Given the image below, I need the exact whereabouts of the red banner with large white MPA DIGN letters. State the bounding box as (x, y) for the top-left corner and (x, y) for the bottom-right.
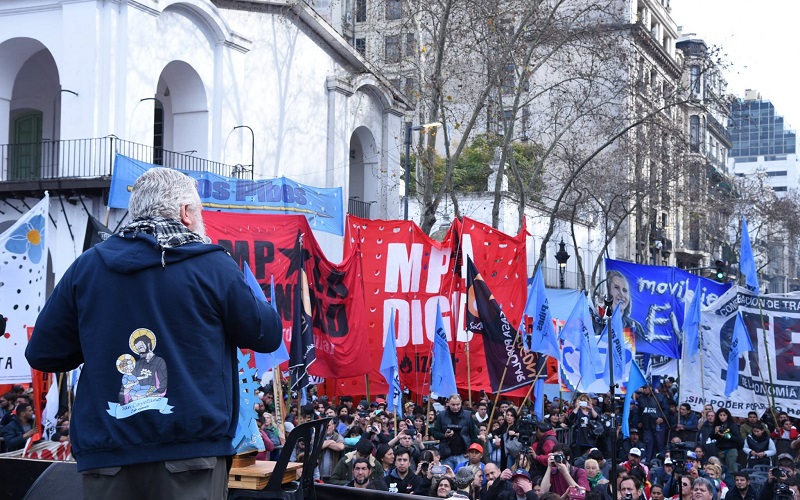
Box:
(336, 216), (527, 396)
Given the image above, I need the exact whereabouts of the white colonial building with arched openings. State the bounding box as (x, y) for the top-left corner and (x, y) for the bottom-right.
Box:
(0, 0), (408, 282)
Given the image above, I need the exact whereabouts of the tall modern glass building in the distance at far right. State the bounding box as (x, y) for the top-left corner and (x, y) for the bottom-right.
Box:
(730, 90), (800, 196)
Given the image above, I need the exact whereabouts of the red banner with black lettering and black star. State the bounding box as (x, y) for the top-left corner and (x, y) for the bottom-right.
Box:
(203, 211), (371, 378)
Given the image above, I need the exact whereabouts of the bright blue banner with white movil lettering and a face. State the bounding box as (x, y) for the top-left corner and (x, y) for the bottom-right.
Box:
(606, 259), (730, 358)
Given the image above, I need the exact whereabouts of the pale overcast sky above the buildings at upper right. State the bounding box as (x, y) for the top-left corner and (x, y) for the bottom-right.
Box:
(671, 0), (800, 130)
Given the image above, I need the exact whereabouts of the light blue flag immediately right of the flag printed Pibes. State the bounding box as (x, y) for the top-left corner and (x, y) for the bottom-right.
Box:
(559, 294), (605, 392)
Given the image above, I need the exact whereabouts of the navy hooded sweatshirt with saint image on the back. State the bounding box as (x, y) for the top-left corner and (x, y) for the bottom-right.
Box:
(26, 232), (281, 471)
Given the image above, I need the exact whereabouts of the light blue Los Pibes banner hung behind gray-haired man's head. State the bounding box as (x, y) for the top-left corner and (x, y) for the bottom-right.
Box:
(108, 154), (344, 236)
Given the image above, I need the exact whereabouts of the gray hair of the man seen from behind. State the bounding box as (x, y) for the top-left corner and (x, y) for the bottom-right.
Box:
(128, 167), (197, 220)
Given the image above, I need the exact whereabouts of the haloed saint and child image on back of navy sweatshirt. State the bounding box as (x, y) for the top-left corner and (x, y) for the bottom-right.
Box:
(106, 328), (172, 419)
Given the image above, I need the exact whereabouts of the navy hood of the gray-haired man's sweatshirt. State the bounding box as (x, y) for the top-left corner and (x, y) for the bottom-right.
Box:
(93, 233), (225, 274)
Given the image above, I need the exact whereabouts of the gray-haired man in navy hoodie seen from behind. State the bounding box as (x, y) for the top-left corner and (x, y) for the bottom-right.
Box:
(25, 167), (282, 498)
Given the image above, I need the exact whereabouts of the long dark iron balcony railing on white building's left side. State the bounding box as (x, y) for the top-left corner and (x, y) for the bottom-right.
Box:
(0, 136), (244, 182)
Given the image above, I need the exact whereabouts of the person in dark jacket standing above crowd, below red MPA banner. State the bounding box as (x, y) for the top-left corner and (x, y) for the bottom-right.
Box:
(431, 394), (478, 469)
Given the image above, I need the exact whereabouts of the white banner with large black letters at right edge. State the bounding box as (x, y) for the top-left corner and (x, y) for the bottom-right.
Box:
(681, 287), (800, 417)
